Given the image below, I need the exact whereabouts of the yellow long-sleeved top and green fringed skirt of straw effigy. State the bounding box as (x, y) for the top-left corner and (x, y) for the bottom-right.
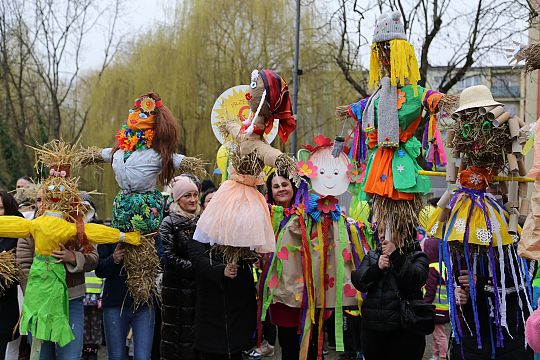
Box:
(0, 211), (141, 346)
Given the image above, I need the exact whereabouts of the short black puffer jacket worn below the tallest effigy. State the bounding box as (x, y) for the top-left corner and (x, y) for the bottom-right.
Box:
(351, 243), (429, 331)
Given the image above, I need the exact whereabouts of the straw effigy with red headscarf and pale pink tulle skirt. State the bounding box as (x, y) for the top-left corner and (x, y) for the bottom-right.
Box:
(193, 70), (296, 263)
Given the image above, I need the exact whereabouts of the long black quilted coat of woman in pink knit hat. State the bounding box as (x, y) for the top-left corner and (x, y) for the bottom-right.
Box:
(159, 213), (197, 360)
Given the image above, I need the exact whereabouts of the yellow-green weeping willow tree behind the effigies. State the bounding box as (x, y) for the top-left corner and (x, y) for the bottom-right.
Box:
(78, 0), (356, 216)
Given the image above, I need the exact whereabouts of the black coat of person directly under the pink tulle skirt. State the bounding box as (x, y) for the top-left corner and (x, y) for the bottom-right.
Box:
(188, 240), (257, 355)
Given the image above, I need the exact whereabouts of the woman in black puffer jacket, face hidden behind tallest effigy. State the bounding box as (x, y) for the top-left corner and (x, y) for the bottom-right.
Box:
(351, 227), (429, 360)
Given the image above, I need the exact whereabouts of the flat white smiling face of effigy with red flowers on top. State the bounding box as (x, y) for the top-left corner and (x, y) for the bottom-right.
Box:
(309, 146), (349, 196)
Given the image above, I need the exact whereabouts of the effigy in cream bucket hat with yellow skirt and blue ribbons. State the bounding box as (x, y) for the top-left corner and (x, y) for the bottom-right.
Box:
(428, 85), (531, 348)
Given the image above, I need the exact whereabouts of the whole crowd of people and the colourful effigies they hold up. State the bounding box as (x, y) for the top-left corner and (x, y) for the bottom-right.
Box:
(0, 7), (540, 360)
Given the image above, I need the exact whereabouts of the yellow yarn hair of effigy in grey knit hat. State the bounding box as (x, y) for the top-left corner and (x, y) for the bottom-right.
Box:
(369, 39), (420, 96)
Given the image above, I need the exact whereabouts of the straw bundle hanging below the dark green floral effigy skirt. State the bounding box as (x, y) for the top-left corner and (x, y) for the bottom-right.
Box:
(123, 234), (161, 309)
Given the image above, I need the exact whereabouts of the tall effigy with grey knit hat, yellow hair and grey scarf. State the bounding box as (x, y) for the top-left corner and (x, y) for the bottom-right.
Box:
(337, 12), (454, 245)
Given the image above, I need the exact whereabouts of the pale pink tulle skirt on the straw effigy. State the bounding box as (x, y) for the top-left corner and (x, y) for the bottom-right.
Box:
(193, 174), (276, 253)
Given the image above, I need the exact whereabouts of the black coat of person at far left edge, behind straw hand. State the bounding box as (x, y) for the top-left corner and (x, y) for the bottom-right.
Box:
(0, 238), (19, 338)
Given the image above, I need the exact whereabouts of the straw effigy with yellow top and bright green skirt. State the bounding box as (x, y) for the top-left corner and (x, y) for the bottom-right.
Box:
(0, 141), (141, 354)
